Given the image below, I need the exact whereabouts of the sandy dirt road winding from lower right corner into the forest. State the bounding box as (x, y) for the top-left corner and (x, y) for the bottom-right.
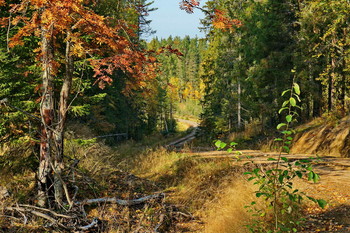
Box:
(168, 123), (350, 233)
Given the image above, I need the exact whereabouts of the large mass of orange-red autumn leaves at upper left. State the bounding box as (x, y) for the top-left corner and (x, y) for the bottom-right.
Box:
(0, 0), (155, 90)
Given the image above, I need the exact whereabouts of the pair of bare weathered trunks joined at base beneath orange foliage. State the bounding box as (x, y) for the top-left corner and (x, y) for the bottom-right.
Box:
(38, 26), (73, 206)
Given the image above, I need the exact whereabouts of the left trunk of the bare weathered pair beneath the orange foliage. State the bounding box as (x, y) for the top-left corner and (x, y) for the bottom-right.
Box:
(38, 23), (54, 206)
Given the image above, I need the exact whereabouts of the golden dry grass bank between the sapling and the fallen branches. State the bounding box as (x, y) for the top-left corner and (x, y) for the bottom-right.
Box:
(129, 149), (268, 233)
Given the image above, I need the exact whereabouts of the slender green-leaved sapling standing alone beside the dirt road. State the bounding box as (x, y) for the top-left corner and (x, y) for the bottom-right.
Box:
(245, 83), (326, 232)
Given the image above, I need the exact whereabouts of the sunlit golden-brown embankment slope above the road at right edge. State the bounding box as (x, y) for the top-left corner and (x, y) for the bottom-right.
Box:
(292, 116), (350, 158)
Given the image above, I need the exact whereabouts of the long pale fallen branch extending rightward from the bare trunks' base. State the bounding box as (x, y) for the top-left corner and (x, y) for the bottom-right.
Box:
(75, 193), (165, 206)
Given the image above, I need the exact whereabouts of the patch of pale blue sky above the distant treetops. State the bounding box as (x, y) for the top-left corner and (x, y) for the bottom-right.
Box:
(147, 0), (205, 39)
